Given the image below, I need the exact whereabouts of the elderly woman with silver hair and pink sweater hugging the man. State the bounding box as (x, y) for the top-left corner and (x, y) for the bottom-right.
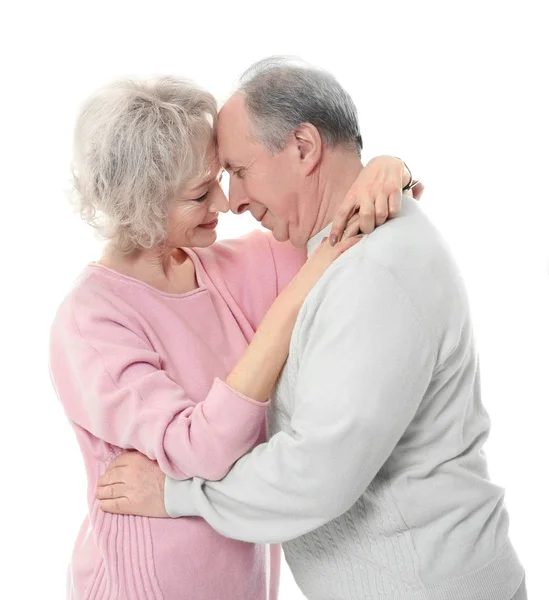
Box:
(51, 78), (416, 600)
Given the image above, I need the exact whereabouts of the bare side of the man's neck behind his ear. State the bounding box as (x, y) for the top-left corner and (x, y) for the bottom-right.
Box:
(309, 150), (362, 239)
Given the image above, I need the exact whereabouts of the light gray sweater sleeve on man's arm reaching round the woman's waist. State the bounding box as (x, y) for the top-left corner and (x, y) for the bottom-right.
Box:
(165, 257), (435, 542)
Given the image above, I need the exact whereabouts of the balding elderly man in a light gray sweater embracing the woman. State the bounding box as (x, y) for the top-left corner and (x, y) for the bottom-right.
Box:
(98, 60), (526, 600)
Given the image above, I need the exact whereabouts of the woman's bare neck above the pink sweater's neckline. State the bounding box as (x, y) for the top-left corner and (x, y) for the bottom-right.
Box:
(98, 246), (198, 294)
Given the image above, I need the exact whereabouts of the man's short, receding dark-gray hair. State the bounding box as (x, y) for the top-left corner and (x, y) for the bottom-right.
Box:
(238, 56), (362, 156)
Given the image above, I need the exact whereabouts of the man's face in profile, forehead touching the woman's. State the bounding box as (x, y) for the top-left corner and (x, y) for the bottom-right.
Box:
(217, 93), (307, 245)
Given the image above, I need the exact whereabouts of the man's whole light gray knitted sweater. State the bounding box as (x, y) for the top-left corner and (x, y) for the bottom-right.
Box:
(165, 197), (523, 600)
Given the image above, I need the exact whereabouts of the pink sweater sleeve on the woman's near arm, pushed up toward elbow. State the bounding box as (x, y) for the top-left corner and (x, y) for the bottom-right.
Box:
(50, 298), (267, 480)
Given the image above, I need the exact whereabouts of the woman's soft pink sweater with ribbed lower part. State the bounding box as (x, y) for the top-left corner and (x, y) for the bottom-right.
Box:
(51, 232), (305, 600)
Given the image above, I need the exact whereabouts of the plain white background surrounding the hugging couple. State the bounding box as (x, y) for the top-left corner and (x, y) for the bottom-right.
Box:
(0, 0), (549, 600)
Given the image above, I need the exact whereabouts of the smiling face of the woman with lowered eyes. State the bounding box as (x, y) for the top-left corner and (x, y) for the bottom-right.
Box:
(167, 144), (229, 248)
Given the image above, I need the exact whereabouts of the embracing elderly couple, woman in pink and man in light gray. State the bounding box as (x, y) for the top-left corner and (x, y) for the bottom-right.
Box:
(50, 58), (526, 600)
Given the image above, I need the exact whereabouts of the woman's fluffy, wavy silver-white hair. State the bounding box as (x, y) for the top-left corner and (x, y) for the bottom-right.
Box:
(73, 77), (217, 252)
